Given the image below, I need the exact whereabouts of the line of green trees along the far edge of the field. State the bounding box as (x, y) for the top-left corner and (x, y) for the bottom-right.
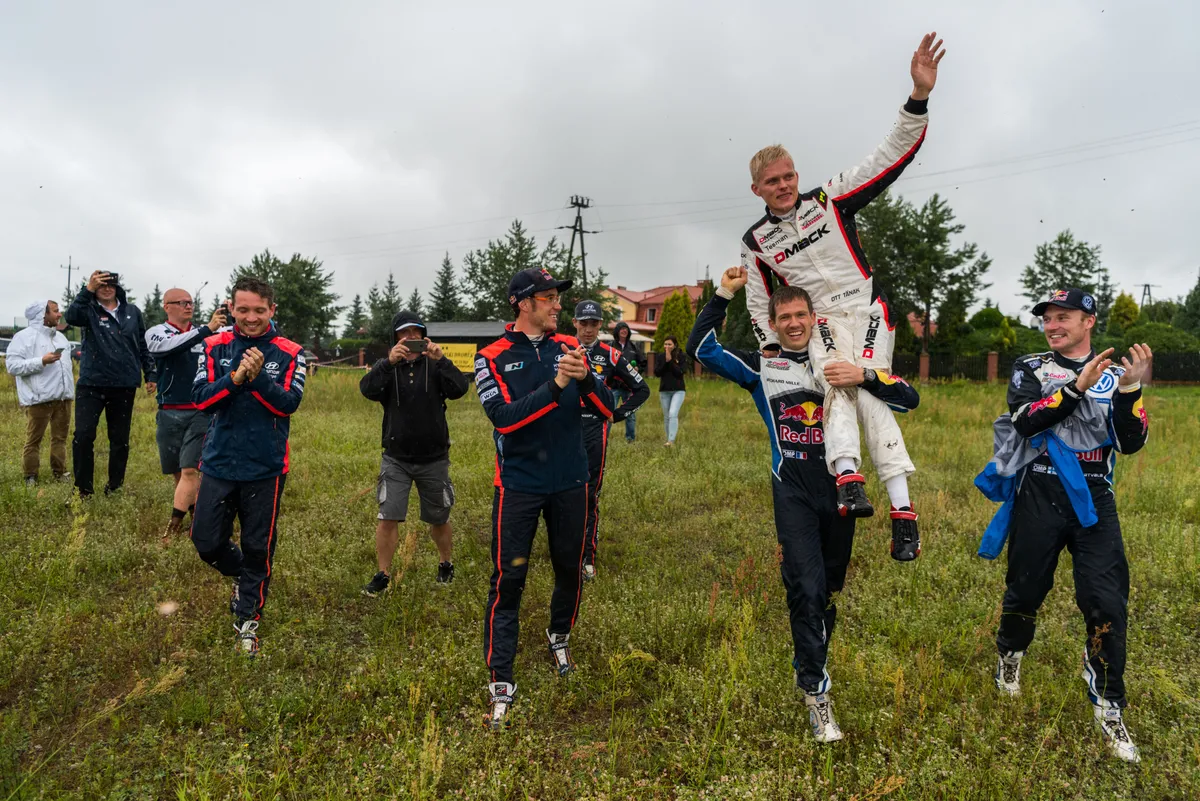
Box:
(54, 192), (1200, 355)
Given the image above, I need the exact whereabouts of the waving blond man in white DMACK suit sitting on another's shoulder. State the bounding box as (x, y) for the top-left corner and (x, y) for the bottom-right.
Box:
(742, 34), (946, 561)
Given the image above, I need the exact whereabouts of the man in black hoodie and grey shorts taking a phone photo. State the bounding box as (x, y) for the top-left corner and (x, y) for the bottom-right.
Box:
(359, 312), (467, 597)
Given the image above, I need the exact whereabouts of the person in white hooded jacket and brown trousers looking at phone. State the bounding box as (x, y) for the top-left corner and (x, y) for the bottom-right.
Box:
(5, 300), (74, 486)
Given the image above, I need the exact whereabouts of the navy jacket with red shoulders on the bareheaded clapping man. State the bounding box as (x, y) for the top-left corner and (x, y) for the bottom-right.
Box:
(192, 324), (305, 481)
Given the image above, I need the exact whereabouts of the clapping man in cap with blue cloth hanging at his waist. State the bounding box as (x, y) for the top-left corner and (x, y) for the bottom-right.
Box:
(996, 288), (1152, 761)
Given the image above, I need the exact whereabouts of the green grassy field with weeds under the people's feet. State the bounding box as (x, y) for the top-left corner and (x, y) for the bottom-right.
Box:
(0, 371), (1200, 801)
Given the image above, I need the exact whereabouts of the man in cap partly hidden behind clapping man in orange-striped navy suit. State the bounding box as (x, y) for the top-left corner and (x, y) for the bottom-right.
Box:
(575, 300), (650, 582)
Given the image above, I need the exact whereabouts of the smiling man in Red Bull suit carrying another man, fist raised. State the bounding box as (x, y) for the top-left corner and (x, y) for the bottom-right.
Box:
(688, 267), (920, 742)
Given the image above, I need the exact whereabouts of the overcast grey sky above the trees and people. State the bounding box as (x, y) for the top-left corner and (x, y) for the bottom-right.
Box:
(0, 0), (1200, 323)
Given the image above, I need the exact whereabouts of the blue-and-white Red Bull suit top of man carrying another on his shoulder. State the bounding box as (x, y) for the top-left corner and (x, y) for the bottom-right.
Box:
(688, 295), (920, 488)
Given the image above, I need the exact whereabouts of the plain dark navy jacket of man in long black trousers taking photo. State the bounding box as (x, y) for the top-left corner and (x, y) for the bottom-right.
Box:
(65, 287), (156, 387)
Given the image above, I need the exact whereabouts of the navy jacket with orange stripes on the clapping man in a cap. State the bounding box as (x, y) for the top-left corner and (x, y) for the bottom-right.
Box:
(475, 323), (612, 495)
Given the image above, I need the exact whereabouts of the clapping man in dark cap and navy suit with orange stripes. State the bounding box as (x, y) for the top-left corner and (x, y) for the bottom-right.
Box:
(475, 269), (612, 729)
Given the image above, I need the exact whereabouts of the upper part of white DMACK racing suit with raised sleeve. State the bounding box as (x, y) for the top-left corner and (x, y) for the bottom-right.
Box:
(742, 97), (929, 344)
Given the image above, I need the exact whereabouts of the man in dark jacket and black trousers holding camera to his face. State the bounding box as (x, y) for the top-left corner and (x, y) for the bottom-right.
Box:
(66, 270), (157, 498)
